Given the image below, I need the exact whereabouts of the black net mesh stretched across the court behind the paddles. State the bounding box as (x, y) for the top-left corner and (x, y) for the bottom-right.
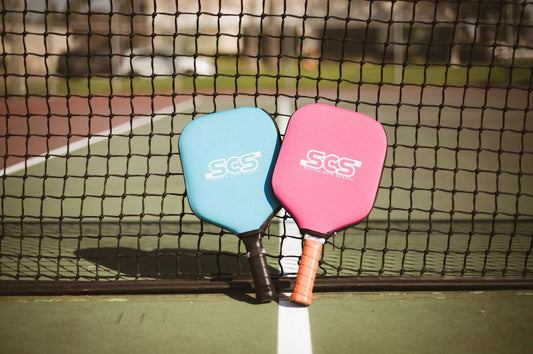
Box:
(0, 0), (533, 291)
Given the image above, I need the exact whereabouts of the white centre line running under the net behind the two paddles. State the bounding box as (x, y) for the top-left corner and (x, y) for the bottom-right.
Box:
(278, 97), (313, 354)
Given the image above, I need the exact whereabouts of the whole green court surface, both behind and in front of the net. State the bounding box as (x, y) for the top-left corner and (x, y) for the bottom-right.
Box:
(0, 91), (533, 354)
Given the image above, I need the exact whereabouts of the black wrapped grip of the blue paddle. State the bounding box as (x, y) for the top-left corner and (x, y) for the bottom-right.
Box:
(240, 232), (277, 303)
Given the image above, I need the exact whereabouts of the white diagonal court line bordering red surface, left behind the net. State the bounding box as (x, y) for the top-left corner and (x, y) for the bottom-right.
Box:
(0, 99), (200, 176)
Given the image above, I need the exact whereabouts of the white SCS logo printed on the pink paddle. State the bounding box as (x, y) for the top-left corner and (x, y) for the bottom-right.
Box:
(300, 150), (362, 179)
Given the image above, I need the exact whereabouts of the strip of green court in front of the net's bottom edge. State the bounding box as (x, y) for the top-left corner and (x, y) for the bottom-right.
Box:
(0, 291), (533, 354)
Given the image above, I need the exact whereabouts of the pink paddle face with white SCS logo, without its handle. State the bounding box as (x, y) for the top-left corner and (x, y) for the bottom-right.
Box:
(272, 103), (387, 236)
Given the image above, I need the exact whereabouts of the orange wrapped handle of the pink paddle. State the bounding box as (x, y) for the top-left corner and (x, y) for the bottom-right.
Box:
(290, 235), (326, 306)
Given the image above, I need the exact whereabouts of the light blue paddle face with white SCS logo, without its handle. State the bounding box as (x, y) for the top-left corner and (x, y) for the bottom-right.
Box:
(179, 107), (280, 234)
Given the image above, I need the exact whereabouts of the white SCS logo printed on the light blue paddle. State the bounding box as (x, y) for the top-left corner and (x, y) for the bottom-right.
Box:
(205, 151), (261, 180)
